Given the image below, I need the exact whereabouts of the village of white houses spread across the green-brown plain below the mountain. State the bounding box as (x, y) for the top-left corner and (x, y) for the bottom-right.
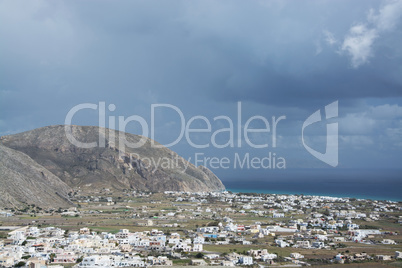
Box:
(0, 189), (402, 268)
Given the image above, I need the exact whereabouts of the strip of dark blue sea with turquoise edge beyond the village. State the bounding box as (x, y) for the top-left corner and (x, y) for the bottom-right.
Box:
(221, 169), (402, 201)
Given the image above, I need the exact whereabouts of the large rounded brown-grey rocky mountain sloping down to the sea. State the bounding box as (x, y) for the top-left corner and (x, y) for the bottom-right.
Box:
(1, 126), (225, 192)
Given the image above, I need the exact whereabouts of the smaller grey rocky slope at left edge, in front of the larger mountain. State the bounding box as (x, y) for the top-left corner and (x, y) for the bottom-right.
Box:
(0, 144), (73, 208)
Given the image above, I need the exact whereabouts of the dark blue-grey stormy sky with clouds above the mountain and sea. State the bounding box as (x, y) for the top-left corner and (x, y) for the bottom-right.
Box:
(0, 0), (402, 178)
